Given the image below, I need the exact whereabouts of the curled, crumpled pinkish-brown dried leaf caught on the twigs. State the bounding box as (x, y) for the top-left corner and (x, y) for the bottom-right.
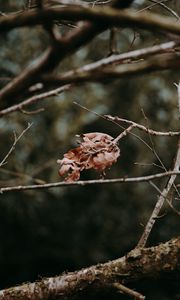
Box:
(57, 132), (120, 181)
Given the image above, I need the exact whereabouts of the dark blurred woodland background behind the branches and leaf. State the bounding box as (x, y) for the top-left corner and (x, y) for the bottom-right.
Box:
(0, 0), (180, 300)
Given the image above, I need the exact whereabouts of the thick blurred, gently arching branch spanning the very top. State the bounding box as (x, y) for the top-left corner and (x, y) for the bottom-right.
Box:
(0, 5), (180, 34)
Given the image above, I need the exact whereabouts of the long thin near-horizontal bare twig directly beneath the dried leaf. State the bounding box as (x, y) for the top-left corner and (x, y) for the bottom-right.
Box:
(0, 171), (180, 193)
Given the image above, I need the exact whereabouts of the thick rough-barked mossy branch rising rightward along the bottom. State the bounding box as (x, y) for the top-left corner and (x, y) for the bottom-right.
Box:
(0, 237), (180, 300)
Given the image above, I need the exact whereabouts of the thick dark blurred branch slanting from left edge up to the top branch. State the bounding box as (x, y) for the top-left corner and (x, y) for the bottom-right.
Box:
(0, 0), (133, 101)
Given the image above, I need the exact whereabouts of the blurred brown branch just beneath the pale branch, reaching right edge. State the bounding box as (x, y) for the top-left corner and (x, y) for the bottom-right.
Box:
(43, 53), (180, 85)
